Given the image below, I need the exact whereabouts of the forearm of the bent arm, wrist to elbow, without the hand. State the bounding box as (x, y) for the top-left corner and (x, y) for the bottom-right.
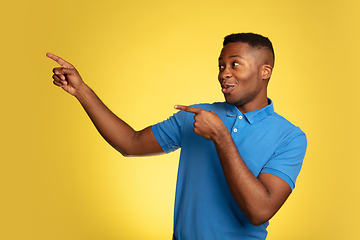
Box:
(213, 132), (278, 225)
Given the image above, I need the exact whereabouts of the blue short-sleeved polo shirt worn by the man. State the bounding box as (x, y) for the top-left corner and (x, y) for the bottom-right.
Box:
(152, 99), (307, 240)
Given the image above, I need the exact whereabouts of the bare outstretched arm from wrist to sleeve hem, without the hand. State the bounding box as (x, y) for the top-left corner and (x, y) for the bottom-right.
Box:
(74, 84), (161, 156)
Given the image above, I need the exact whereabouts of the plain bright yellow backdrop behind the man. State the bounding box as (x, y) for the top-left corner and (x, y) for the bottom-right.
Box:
(0, 0), (360, 240)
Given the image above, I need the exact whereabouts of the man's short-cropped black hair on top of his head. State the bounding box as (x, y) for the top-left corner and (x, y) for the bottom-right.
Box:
(223, 33), (275, 63)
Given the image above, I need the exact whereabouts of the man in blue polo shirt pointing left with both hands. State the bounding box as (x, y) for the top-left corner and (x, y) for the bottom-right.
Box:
(47, 33), (307, 240)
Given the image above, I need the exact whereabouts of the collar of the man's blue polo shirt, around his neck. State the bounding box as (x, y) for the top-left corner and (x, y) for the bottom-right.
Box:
(226, 98), (274, 124)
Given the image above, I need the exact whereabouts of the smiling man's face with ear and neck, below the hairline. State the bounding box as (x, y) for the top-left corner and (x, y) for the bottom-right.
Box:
(218, 42), (272, 112)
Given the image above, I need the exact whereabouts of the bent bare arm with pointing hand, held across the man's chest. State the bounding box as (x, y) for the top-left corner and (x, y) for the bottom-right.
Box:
(175, 105), (291, 225)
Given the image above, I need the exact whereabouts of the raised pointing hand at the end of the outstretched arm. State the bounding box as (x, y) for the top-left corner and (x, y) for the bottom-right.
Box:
(46, 53), (84, 96)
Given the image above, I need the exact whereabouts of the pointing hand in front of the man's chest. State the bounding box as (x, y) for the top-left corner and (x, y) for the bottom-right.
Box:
(174, 105), (229, 140)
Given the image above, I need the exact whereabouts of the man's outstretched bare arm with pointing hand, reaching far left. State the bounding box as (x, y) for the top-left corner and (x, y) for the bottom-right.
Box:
(46, 53), (163, 156)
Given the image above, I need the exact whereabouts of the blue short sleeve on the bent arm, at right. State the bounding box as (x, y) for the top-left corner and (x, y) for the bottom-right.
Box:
(261, 127), (307, 190)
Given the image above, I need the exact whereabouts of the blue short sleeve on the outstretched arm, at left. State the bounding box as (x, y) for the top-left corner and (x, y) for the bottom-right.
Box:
(152, 111), (187, 153)
